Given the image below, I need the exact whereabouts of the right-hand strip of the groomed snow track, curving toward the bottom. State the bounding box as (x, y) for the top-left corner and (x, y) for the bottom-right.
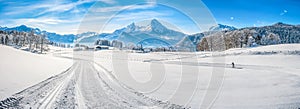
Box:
(90, 62), (186, 109)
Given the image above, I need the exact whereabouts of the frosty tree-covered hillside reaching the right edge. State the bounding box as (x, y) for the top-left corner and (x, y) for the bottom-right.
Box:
(198, 23), (300, 51)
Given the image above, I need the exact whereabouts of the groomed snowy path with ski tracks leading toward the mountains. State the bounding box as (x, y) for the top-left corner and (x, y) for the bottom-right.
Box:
(0, 52), (182, 109)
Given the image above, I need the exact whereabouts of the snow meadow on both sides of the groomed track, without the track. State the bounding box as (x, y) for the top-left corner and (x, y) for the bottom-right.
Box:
(0, 44), (300, 109)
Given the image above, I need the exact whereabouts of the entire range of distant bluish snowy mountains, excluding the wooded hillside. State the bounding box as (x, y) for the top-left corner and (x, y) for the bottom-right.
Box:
(0, 19), (235, 46)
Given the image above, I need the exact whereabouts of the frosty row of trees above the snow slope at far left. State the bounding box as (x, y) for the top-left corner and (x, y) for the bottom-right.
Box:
(0, 31), (49, 53)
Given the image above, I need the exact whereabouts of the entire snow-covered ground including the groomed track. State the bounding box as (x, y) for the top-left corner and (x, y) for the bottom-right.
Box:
(0, 44), (300, 109)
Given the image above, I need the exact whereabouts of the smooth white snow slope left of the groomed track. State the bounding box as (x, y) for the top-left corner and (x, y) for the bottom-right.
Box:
(0, 45), (72, 100)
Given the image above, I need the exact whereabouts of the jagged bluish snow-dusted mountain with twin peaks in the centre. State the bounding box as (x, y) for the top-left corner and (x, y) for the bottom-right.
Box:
(80, 19), (186, 45)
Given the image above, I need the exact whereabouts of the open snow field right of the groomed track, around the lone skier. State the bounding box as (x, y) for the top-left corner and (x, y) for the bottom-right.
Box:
(94, 44), (300, 109)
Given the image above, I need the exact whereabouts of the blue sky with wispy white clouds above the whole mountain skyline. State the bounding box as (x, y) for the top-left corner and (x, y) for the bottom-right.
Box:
(0, 0), (300, 34)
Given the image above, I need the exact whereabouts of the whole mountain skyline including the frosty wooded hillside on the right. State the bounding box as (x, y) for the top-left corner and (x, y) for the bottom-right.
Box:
(0, 19), (300, 51)
